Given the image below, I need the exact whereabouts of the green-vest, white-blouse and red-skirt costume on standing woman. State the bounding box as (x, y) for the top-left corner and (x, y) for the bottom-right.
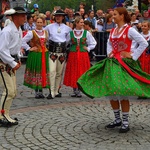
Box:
(64, 29), (96, 97)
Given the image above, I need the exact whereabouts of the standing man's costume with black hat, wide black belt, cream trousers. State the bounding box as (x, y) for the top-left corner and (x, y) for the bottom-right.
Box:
(45, 10), (72, 99)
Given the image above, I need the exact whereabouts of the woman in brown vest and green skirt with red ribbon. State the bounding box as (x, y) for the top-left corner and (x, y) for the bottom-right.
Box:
(22, 17), (50, 99)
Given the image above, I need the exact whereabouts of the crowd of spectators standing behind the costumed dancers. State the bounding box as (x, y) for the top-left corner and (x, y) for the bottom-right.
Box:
(1, 2), (150, 61)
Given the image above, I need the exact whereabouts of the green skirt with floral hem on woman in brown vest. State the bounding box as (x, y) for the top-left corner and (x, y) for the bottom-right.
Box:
(24, 52), (50, 89)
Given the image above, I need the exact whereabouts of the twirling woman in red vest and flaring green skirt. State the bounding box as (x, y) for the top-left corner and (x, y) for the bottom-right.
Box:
(78, 7), (150, 133)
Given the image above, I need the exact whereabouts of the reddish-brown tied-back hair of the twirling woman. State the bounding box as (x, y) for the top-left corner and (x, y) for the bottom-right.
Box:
(114, 7), (131, 23)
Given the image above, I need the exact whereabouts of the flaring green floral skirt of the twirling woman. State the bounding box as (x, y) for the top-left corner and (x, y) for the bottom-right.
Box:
(77, 58), (150, 98)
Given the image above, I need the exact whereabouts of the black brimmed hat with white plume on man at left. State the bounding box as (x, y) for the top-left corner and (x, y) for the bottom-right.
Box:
(4, 7), (27, 15)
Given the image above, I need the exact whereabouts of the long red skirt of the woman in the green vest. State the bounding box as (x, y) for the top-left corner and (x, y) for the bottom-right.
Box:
(64, 52), (90, 88)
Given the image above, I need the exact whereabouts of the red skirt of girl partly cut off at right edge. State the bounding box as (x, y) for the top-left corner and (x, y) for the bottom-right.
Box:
(139, 50), (150, 74)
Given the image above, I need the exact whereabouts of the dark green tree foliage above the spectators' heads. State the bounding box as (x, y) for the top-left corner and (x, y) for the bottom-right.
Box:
(29, 0), (116, 12)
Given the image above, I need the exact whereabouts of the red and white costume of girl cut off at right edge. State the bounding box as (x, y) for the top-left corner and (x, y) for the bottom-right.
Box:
(139, 31), (150, 74)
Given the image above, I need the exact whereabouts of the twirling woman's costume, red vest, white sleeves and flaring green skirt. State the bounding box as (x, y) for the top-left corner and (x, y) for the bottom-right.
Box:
(78, 24), (150, 100)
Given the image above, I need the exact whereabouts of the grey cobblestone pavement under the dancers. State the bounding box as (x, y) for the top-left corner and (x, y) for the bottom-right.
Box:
(0, 65), (150, 150)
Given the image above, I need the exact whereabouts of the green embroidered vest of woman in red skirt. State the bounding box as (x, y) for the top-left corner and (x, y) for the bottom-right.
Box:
(70, 30), (87, 52)
